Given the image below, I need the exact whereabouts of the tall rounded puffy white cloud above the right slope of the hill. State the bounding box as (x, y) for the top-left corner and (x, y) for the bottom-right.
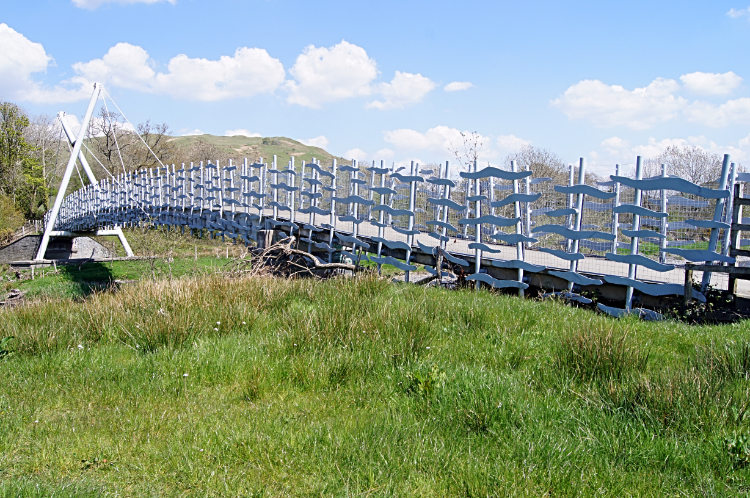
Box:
(287, 40), (378, 108)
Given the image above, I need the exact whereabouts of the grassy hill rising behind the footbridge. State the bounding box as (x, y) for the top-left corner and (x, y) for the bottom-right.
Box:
(170, 135), (351, 167)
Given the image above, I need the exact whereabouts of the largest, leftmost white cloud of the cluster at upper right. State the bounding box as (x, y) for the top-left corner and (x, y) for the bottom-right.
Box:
(551, 78), (687, 130)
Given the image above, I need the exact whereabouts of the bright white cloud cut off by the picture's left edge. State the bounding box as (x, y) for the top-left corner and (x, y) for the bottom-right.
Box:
(0, 23), (93, 104)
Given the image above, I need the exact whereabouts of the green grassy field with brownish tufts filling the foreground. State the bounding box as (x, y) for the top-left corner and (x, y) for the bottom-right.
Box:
(0, 270), (750, 497)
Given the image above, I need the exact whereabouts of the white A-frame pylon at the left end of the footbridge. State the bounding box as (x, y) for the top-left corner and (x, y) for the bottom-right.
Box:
(35, 83), (133, 261)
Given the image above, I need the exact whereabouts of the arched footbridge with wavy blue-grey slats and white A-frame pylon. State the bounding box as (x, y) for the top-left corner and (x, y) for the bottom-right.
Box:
(36, 84), (750, 316)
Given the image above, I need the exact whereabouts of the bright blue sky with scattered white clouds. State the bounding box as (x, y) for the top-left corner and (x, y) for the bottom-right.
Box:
(0, 0), (750, 174)
